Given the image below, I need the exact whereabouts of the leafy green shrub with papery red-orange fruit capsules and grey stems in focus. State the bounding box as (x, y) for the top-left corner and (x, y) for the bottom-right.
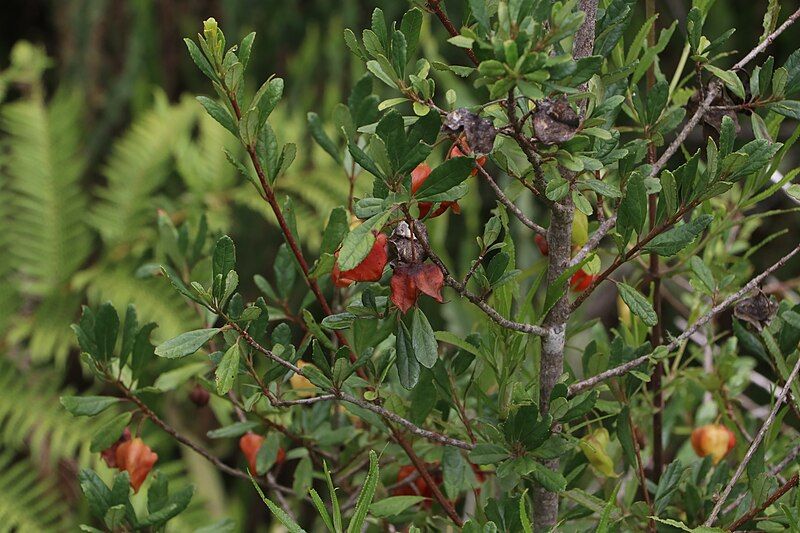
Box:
(63, 0), (800, 531)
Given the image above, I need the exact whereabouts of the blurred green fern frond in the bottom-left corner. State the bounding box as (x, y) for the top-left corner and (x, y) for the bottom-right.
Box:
(0, 446), (76, 533)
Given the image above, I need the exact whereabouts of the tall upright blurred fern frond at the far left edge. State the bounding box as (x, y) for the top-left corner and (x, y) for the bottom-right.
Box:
(0, 88), (92, 295)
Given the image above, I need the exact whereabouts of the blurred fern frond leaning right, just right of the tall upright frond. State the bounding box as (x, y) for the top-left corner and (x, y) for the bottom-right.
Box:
(91, 95), (195, 246)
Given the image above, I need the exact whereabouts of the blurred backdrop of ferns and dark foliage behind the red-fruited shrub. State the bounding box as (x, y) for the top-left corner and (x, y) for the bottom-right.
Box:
(0, 0), (797, 531)
